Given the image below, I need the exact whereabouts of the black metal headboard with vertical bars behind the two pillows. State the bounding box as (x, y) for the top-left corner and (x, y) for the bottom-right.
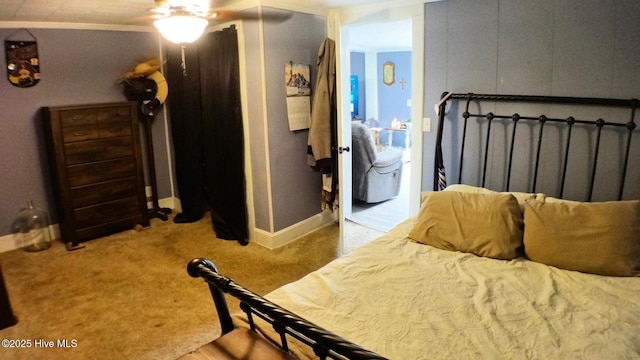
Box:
(433, 92), (640, 201)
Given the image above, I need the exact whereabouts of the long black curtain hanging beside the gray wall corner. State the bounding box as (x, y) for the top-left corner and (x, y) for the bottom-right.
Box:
(167, 27), (248, 245)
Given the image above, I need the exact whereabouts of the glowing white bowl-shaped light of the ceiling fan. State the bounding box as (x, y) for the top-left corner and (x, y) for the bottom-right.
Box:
(153, 15), (209, 44)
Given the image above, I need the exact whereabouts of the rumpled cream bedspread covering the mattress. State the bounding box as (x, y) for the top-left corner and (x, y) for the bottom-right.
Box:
(239, 220), (640, 359)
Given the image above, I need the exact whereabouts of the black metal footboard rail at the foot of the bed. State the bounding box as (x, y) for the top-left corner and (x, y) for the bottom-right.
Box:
(187, 259), (385, 360)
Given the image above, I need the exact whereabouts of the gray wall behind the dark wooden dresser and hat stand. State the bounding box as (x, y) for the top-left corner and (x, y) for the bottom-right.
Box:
(0, 29), (170, 235)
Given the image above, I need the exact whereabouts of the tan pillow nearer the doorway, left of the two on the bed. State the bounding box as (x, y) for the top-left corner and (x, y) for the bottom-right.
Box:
(409, 191), (522, 260)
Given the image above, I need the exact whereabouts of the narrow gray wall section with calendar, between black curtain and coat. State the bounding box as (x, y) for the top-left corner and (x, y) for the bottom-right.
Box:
(262, 9), (327, 231)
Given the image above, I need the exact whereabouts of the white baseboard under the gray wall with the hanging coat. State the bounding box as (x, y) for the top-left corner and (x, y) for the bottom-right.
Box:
(251, 211), (338, 250)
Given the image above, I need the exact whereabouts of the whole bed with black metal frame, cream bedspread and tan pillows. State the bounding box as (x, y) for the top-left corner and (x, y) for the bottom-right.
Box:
(182, 92), (640, 359)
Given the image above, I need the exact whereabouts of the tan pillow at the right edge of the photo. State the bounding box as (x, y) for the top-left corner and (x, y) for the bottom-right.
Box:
(524, 199), (640, 276)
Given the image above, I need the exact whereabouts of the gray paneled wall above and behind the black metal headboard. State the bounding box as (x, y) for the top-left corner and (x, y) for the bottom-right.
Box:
(422, 0), (640, 198)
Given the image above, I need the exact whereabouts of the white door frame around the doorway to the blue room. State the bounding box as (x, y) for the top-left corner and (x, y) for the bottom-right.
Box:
(329, 4), (424, 252)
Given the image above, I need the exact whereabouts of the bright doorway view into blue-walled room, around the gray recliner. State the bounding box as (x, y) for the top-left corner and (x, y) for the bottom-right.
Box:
(342, 19), (421, 231)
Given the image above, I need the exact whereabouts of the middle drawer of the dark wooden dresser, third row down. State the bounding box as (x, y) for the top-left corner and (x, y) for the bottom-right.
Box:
(67, 157), (136, 188)
